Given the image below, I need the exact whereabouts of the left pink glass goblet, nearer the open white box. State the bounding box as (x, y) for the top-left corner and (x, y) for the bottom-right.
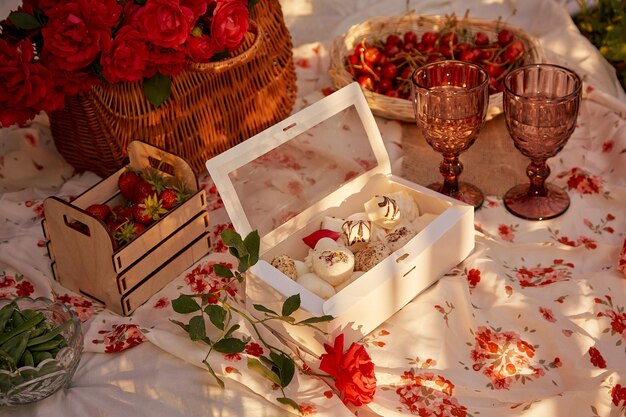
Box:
(411, 60), (489, 209)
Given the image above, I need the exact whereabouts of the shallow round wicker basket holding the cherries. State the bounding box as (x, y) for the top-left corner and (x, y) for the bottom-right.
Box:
(328, 14), (545, 122)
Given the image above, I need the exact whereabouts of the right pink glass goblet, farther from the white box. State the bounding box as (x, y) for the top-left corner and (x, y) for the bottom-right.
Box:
(504, 64), (582, 220)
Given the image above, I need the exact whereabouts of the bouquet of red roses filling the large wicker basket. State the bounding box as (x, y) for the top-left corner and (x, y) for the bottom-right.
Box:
(0, 0), (256, 127)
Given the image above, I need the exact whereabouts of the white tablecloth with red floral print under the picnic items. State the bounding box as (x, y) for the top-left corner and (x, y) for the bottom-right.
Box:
(0, 3), (626, 417)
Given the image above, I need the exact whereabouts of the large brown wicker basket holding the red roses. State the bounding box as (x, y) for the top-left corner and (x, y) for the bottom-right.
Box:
(50, 0), (296, 177)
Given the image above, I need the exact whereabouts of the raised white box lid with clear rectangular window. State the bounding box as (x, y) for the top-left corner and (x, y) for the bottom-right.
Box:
(206, 83), (391, 253)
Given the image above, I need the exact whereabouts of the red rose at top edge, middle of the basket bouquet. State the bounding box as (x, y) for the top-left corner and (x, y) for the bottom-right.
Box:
(136, 0), (193, 48)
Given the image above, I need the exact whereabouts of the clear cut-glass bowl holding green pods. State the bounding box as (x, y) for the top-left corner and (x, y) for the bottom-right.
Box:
(0, 297), (83, 406)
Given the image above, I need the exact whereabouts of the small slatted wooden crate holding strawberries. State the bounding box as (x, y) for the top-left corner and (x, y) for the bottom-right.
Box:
(42, 141), (210, 315)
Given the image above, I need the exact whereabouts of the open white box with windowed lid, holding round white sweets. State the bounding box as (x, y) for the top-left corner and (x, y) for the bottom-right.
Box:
(207, 83), (474, 355)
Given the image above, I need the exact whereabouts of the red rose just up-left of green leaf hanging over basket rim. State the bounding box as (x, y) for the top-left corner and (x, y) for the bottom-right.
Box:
(100, 26), (148, 83)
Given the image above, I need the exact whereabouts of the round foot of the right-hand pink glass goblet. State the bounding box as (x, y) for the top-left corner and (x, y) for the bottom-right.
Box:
(503, 184), (569, 220)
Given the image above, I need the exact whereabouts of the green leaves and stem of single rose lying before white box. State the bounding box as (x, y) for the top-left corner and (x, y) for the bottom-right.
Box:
(166, 229), (333, 410)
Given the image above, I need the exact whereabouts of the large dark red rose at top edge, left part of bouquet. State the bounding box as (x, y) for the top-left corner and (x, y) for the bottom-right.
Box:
(41, 0), (111, 71)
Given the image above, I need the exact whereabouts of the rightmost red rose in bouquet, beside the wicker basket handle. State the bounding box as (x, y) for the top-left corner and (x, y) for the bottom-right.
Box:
(211, 0), (250, 50)
